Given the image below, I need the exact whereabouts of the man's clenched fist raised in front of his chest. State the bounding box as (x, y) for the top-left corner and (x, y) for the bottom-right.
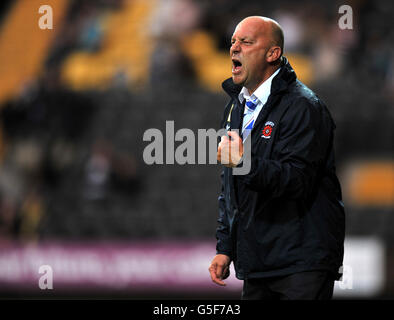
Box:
(217, 131), (244, 168)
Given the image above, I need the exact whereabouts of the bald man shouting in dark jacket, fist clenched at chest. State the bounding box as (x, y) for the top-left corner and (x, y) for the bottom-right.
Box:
(209, 17), (345, 300)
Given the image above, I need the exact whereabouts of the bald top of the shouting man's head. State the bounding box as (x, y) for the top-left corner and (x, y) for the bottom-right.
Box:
(235, 16), (284, 56)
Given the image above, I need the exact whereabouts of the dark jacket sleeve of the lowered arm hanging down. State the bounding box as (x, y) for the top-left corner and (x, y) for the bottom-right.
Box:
(216, 170), (233, 259)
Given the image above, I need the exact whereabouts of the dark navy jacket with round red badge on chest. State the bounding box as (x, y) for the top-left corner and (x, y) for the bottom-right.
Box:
(216, 57), (345, 279)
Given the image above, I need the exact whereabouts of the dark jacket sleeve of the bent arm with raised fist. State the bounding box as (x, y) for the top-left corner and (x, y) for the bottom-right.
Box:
(240, 97), (332, 198)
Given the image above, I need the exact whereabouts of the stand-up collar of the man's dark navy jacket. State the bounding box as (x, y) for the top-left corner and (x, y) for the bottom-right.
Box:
(222, 56), (297, 99)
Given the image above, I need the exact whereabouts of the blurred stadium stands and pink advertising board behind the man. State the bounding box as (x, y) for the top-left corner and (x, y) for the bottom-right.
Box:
(0, 0), (394, 299)
